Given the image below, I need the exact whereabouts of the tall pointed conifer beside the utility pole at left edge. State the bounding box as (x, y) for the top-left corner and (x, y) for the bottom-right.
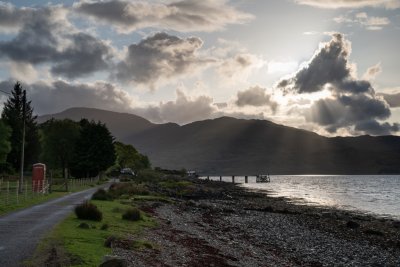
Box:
(1, 82), (40, 173)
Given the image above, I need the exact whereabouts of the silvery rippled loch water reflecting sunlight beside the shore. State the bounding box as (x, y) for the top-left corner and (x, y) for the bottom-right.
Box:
(203, 175), (400, 219)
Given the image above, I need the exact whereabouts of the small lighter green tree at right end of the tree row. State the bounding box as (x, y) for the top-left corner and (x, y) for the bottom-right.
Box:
(114, 142), (151, 172)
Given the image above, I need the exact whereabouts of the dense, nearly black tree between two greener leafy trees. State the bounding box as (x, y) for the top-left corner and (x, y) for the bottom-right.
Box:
(71, 119), (116, 177)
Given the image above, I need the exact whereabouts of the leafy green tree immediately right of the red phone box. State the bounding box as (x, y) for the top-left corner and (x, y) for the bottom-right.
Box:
(41, 119), (80, 178)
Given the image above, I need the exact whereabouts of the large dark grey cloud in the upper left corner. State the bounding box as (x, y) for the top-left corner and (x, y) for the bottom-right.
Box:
(0, 6), (112, 78)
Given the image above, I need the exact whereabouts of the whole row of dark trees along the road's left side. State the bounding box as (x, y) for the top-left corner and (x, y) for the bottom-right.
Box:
(0, 82), (150, 178)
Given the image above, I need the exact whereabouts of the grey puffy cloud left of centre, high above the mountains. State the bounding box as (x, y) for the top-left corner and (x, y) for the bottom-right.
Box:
(115, 33), (213, 87)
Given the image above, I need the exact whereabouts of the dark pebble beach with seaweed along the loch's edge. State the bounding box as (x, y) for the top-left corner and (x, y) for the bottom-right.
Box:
(113, 179), (400, 267)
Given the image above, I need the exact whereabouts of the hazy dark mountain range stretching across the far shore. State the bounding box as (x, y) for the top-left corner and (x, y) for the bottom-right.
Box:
(39, 108), (400, 175)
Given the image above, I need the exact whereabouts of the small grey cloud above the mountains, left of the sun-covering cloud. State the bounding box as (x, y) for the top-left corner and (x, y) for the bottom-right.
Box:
(235, 86), (278, 113)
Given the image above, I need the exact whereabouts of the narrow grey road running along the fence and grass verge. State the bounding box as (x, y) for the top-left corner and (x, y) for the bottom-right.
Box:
(0, 187), (105, 267)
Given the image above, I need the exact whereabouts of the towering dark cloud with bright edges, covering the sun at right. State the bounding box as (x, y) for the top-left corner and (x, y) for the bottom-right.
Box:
(278, 34), (398, 135)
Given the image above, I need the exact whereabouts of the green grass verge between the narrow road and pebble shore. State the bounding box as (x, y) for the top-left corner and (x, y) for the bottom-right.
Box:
(25, 200), (156, 267)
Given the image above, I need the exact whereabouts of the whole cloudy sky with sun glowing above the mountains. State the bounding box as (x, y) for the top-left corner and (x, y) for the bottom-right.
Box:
(0, 0), (400, 136)
